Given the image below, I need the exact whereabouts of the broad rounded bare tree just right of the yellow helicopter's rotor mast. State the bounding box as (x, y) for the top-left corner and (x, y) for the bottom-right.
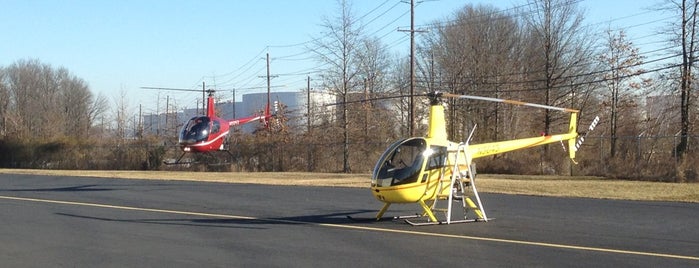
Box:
(419, 5), (522, 140)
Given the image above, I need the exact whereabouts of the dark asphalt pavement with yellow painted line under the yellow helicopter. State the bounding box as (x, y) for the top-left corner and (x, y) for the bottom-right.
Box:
(0, 173), (699, 267)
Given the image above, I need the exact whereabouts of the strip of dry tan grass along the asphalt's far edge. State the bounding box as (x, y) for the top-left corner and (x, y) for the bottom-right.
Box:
(0, 169), (699, 203)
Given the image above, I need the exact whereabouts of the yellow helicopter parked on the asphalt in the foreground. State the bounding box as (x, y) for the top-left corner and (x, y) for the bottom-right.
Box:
(371, 92), (599, 225)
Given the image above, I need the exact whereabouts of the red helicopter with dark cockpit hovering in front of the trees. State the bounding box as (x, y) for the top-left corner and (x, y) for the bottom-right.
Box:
(143, 87), (276, 165)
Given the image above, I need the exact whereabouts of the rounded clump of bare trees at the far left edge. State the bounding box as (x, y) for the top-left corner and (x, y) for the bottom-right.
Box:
(0, 60), (105, 167)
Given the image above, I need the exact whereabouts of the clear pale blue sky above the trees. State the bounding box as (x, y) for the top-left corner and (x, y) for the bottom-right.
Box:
(0, 0), (669, 113)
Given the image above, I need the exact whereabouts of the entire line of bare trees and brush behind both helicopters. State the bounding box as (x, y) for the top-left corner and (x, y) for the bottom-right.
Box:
(0, 0), (699, 181)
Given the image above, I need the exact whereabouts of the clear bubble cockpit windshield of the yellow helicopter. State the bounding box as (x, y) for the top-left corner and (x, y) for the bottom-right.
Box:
(371, 138), (428, 187)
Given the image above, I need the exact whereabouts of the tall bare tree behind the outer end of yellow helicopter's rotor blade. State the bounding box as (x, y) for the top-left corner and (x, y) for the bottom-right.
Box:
(525, 0), (595, 133)
